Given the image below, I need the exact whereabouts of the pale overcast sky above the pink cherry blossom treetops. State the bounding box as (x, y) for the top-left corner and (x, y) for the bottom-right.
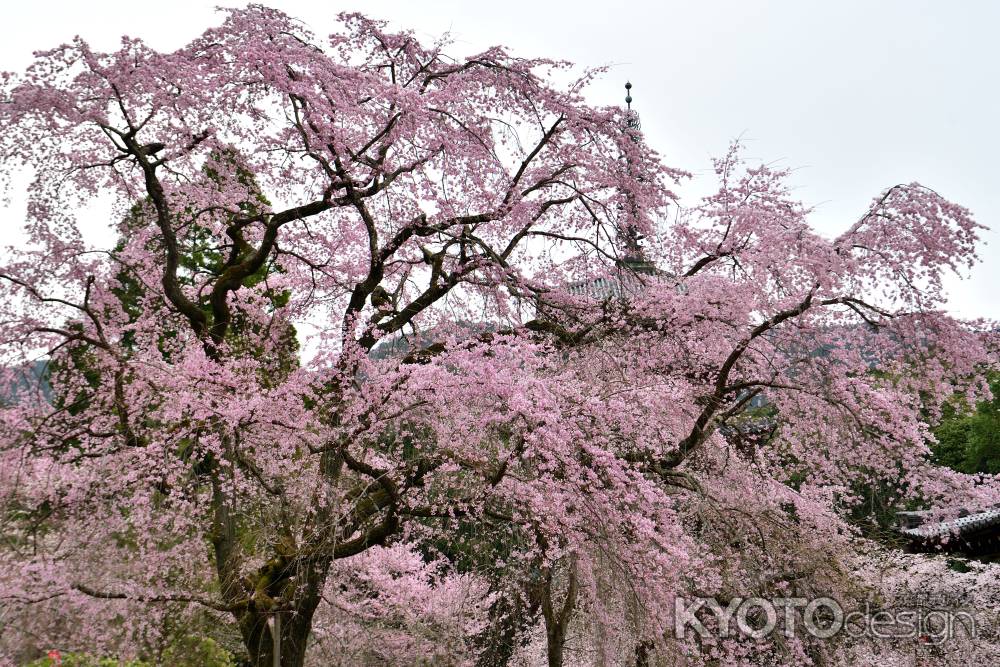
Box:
(0, 0), (1000, 318)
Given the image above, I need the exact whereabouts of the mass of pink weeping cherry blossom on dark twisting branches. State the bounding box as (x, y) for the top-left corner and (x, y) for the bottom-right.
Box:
(0, 5), (1000, 667)
